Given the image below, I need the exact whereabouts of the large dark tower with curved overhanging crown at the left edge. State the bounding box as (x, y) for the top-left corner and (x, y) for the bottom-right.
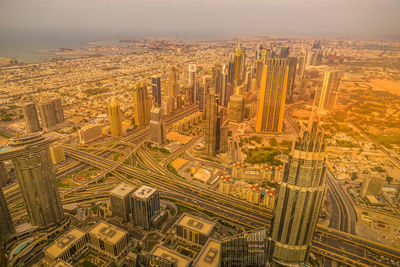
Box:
(0, 134), (64, 227)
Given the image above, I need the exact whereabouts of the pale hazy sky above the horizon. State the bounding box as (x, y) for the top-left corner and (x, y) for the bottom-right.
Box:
(0, 0), (400, 35)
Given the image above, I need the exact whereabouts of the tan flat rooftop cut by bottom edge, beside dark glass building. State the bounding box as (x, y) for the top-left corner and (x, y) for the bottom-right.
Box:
(193, 238), (221, 267)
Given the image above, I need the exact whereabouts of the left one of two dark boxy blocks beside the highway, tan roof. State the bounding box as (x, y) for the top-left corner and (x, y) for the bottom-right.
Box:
(110, 183), (135, 222)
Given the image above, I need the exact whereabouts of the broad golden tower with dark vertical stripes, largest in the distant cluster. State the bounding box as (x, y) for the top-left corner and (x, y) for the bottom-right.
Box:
(256, 59), (289, 133)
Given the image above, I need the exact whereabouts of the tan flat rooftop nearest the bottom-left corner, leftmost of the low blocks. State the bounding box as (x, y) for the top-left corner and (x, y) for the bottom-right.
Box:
(44, 228), (86, 258)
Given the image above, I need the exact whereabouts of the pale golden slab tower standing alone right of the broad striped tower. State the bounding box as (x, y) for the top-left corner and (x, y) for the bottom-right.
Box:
(317, 70), (340, 110)
